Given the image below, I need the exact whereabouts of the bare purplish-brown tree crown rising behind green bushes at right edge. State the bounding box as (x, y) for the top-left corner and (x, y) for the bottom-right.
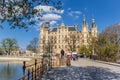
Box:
(102, 23), (120, 54)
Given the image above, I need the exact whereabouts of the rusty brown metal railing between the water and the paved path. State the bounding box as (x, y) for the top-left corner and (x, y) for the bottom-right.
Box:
(18, 58), (60, 80)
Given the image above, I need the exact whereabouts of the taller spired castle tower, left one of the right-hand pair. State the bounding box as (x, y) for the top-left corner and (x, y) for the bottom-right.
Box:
(81, 16), (89, 46)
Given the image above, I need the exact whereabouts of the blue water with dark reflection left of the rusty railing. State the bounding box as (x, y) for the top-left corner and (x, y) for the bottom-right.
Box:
(0, 62), (22, 80)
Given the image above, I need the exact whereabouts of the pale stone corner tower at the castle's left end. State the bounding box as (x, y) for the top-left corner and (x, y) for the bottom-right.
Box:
(39, 22), (48, 53)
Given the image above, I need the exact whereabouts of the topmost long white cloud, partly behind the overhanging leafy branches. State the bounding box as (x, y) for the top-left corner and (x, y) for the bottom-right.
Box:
(35, 5), (64, 14)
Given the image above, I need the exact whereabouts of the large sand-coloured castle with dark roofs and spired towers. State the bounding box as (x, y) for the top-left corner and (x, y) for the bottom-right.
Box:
(39, 17), (97, 53)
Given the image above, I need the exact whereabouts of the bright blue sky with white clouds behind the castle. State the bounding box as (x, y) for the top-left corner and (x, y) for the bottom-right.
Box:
(0, 0), (120, 50)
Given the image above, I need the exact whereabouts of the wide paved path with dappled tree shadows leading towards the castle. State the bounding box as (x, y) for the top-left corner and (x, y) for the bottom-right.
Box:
(39, 59), (120, 80)
